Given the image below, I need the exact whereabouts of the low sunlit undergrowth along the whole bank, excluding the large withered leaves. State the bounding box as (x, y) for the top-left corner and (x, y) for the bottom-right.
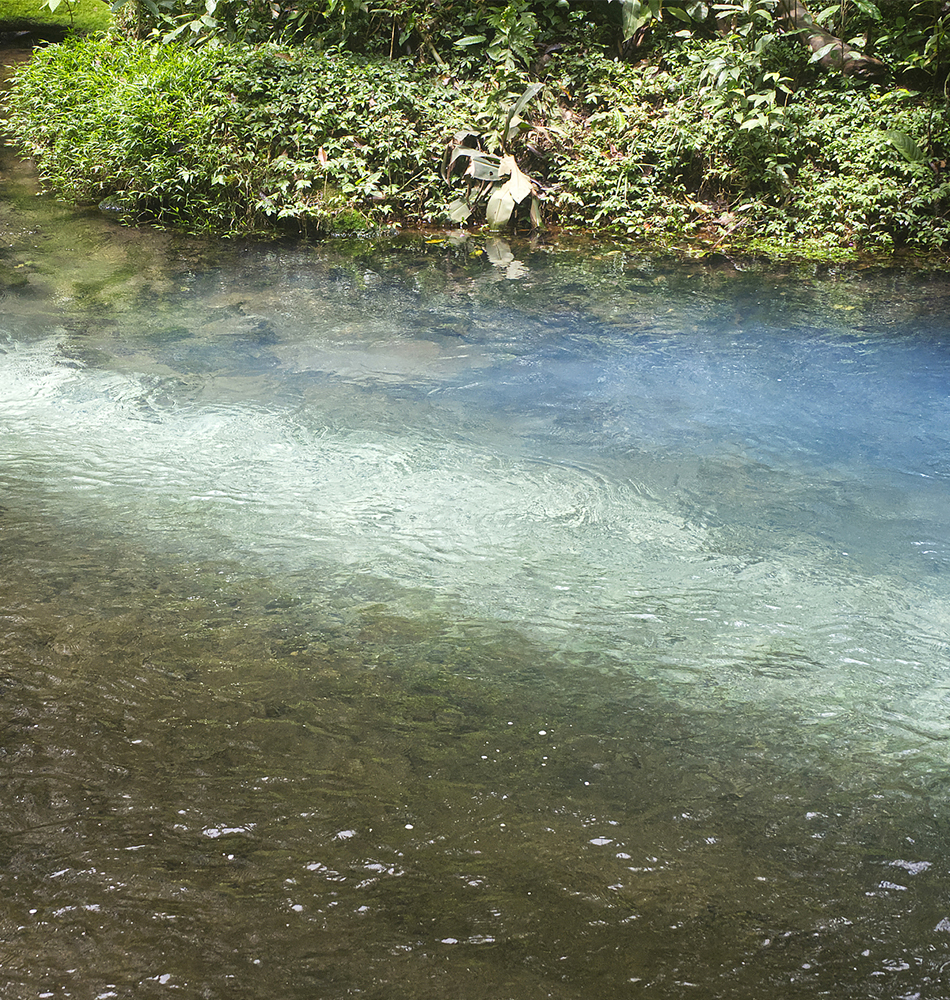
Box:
(6, 16), (950, 254)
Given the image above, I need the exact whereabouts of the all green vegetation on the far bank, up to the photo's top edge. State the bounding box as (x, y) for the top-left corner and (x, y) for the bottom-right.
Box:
(7, 0), (950, 255)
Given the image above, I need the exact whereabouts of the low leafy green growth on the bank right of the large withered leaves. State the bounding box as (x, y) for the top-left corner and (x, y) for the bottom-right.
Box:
(535, 38), (950, 248)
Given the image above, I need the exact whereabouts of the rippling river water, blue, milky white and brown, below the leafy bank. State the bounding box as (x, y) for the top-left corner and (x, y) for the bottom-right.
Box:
(0, 97), (950, 1000)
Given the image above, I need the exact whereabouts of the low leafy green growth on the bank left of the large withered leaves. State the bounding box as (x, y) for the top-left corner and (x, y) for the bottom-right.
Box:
(0, 41), (488, 233)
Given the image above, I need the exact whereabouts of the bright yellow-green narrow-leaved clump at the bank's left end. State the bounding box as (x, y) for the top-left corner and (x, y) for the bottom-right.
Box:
(8, 39), (240, 224)
